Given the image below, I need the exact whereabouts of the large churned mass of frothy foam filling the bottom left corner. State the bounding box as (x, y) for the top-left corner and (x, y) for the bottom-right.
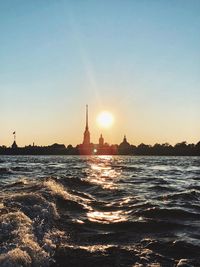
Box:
(0, 184), (65, 267)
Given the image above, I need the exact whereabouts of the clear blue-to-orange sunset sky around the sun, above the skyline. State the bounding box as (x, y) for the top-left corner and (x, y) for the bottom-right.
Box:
(0, 0), (200, 146)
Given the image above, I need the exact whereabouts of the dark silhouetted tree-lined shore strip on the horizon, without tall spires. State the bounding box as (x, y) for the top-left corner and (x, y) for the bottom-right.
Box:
(0, 141), (200, 156)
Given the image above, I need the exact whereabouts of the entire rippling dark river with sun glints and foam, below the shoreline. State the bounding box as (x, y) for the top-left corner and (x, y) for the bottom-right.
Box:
(0, 156), (200, 267)
